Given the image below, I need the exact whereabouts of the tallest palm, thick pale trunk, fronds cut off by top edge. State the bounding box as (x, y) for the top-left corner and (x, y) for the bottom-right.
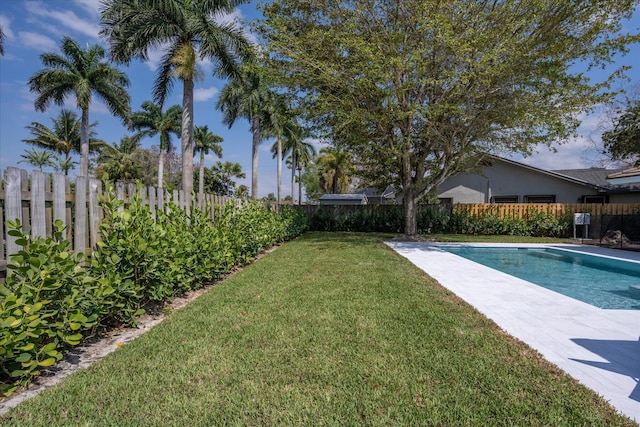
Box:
(101, 0), (251, 194)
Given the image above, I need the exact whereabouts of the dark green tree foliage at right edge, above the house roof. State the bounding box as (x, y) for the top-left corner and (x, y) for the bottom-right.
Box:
(602, 100), (640, 166)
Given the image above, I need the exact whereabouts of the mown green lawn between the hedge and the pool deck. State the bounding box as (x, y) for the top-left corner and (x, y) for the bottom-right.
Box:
(0, 233), (635, 426)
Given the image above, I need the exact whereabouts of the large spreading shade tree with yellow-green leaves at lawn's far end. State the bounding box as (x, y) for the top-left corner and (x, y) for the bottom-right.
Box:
(262, 0), (637, 236)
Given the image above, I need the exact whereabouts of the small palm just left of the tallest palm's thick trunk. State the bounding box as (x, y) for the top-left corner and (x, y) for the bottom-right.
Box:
(130, 101), (182, 188)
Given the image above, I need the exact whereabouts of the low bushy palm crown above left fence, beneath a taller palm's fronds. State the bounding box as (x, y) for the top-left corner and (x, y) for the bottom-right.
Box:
(22, 108), (106, 175)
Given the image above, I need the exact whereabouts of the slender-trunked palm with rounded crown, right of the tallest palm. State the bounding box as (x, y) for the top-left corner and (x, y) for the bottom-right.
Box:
(216, 70), (273, 199)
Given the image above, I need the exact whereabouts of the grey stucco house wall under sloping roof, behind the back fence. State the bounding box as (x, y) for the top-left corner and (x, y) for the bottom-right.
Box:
(438, 159), (599, 203)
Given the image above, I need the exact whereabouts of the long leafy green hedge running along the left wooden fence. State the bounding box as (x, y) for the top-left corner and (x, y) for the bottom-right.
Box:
(0, 187), (306, 395)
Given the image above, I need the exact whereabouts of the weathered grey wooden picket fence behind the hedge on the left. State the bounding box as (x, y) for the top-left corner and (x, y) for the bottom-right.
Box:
(0, 168), (240, 272)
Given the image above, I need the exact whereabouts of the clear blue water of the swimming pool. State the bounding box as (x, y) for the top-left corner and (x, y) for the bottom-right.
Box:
(440, 246), (640, 310)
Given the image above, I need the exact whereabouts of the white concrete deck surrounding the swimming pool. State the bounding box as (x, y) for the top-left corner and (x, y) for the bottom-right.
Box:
(386, 241), (640, 422)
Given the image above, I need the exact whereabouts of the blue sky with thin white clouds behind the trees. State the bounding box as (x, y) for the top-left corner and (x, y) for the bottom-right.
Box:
(0, 0), (640, 197)
